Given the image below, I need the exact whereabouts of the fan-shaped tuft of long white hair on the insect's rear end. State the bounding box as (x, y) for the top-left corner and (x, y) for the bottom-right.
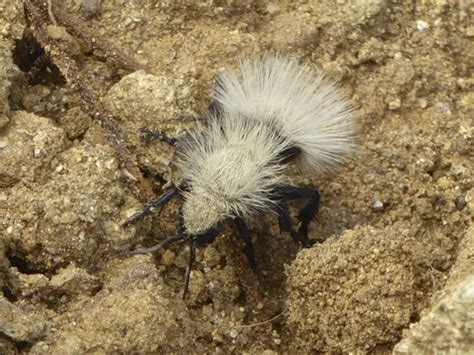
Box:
(214, 55), (355, 172)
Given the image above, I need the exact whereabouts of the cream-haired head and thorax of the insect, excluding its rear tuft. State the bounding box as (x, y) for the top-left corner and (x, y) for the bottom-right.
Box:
(180, 113), (290, 235)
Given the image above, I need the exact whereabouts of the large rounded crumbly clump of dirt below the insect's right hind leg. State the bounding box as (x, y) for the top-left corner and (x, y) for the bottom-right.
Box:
(286, 223), (434, 353)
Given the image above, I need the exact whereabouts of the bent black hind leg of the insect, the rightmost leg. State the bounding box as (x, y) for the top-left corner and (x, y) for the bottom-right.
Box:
(280, 186), (320, 239)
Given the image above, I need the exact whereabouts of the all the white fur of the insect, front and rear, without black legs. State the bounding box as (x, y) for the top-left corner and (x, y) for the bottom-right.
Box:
(180, 56), (354, 235)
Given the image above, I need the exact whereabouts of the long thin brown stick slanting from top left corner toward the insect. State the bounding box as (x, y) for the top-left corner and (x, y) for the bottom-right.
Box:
(23, 0), (154, 202)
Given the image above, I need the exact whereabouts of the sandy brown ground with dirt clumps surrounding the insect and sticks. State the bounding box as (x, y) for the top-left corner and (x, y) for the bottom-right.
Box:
(0, 0), (474, 355)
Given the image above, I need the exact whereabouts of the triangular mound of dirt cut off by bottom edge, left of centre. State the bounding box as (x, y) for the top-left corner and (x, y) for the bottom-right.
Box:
(31, 256), (206, 354)
